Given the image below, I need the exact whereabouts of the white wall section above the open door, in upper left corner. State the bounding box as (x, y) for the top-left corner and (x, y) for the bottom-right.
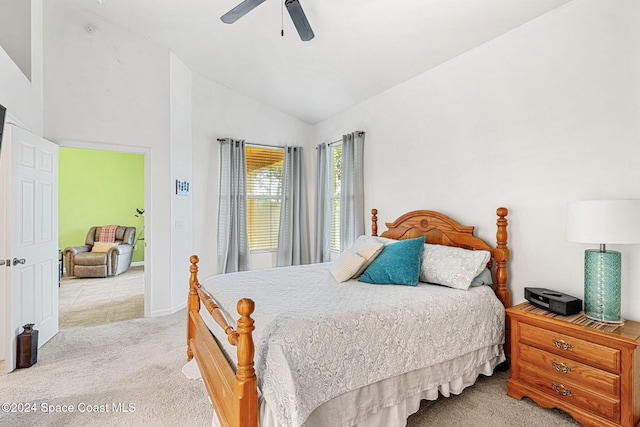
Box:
(0, 0), (42, 135)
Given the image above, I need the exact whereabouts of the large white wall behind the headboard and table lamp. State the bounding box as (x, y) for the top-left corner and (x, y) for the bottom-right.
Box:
(315, 0), (640, 320)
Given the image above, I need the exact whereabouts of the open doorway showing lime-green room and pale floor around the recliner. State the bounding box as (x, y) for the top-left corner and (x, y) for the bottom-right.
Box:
(59, 141), (150, 329)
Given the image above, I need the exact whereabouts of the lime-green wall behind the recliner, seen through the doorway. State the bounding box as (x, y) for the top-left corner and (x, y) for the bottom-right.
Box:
(58, 147), (144, 262)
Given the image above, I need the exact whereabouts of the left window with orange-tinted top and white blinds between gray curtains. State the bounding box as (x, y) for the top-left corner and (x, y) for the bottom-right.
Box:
(246, 146), (284, 251)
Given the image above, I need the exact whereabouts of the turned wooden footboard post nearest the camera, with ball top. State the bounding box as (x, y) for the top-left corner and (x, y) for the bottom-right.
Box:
(236, 298), (258, 427)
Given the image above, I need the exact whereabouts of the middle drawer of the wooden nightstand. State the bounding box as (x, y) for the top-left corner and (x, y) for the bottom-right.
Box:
(519, 344), (620, 399)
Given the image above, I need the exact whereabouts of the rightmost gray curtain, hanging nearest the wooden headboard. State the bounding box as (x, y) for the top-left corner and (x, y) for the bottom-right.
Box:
(340, 132), (364, 251)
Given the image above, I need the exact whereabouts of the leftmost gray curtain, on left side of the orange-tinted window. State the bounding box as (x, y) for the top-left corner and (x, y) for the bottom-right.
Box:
(218, 139), (249, 273)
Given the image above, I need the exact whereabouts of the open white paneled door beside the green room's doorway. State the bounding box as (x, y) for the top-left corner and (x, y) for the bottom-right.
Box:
(0, 125), (59, 372)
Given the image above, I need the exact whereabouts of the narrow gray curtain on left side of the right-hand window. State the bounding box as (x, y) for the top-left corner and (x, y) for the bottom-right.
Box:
(315, 143), (333, 262)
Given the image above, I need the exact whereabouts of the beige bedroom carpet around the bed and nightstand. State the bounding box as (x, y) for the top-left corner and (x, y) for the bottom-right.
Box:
(0, 310), (578, 427)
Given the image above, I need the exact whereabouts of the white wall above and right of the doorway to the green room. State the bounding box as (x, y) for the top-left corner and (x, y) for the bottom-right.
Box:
(44, 2), (174, 315)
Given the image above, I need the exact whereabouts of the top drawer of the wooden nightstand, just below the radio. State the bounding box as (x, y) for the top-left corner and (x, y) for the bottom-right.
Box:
(520, 322), (620, 373)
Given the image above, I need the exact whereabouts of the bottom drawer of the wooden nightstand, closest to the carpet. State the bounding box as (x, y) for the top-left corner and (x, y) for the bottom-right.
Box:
(520, 366), (620, 423)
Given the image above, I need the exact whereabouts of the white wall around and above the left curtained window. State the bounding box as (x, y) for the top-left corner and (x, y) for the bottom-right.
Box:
(193, 72), (315, 278)
